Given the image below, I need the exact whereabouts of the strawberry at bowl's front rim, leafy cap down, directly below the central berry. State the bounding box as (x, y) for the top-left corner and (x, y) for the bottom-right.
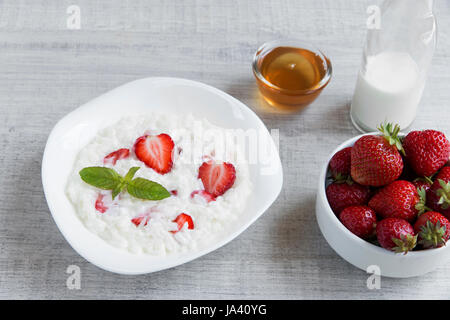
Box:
(376, 218), (417, 254)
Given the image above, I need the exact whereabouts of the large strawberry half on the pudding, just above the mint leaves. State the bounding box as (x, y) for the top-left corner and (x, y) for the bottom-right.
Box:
(134, 133), (175, 174)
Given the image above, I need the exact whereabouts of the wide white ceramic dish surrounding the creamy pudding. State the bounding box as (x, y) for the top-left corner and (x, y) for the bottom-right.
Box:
(42, 78), (283, 274)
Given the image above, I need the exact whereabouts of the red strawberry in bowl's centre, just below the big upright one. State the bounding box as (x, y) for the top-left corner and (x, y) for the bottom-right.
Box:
(369, 180), (425, 222)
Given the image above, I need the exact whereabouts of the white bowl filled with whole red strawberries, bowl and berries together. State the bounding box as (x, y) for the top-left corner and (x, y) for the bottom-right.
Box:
(316, 124), (450, 278)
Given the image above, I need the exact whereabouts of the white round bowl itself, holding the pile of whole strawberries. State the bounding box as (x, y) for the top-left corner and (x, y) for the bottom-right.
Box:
(316, 133), (450, 278)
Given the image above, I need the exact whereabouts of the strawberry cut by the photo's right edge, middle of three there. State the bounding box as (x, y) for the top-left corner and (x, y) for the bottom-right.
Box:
(427, 167), (450, 219)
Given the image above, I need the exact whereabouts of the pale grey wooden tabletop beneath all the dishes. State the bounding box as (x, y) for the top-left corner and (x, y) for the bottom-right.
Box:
(0, 0), (450, 299)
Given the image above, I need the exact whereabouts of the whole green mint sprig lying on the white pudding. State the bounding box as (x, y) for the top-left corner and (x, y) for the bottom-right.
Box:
(80, 167), (170, 200)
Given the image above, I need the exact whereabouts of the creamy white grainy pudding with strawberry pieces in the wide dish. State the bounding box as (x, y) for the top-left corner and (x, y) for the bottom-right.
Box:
(66, 113), (251, 256)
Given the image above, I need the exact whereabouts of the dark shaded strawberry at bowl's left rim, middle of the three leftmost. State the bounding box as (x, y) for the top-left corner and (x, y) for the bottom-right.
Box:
(326, 182), (370, 214)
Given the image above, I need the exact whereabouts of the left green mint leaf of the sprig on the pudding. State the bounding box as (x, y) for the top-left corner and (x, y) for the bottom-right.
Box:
(80, 167), (123, 190)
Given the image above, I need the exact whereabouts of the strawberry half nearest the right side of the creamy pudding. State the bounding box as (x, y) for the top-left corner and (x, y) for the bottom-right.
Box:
(198, 161), (236, 197)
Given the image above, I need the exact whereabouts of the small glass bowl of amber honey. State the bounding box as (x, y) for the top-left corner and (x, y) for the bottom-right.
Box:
(253, 40), (332, 111)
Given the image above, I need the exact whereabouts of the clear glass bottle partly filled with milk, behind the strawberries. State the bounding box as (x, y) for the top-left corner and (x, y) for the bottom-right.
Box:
(350, 0), (436, 132)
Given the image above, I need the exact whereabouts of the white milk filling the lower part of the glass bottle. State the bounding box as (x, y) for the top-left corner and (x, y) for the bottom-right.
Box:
(352, 51), (425, 131)
